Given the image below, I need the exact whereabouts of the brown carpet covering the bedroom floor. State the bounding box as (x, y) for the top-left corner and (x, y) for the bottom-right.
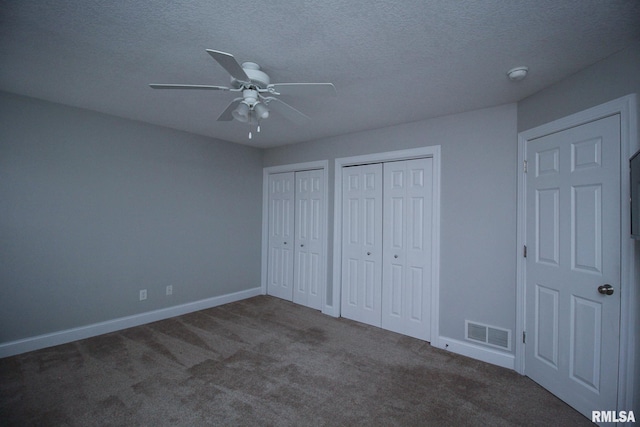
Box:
(0, 296), (591, 426)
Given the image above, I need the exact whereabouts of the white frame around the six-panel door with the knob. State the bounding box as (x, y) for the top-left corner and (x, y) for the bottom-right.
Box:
(515, 94), (638, 411)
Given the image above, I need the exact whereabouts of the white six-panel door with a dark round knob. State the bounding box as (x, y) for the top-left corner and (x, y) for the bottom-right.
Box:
(525, 115), (621, 417)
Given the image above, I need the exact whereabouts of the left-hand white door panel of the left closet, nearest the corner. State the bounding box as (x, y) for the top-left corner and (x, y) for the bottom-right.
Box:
(267, 172), (295, 301)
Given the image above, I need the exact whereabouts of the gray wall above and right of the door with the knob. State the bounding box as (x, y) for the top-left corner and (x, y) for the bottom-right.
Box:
(518, 43), (640, 411)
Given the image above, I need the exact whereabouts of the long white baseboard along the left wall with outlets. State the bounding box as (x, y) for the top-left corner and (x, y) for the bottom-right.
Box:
(0, 287), (262, 358)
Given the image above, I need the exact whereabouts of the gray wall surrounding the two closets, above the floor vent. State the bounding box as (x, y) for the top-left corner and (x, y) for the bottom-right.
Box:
(264, 104), (517, 348)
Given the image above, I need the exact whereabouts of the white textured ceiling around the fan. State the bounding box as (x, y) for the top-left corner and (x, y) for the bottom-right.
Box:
(0, 0), (640, 147)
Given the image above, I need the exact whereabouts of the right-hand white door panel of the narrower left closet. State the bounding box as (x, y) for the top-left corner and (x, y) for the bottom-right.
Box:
(293, 169), (325, 310)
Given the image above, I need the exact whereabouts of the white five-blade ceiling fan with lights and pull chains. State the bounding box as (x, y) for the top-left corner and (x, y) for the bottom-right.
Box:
(149, 49), (336, 138)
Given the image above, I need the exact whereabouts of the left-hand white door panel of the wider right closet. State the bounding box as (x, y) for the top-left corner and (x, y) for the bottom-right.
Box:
(341, 163), (382, 326)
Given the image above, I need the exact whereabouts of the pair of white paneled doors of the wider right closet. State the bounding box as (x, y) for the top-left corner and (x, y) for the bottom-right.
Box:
(341, 158), (434, 341)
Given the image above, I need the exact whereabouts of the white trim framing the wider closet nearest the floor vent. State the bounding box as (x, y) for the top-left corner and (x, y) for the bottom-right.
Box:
(326, 145), (441, 346)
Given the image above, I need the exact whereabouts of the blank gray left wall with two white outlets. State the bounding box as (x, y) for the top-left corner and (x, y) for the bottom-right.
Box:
(0, 93), (262, 343)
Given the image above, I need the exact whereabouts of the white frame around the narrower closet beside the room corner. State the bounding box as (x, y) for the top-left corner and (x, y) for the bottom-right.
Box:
(260, 160), (329, 313)
